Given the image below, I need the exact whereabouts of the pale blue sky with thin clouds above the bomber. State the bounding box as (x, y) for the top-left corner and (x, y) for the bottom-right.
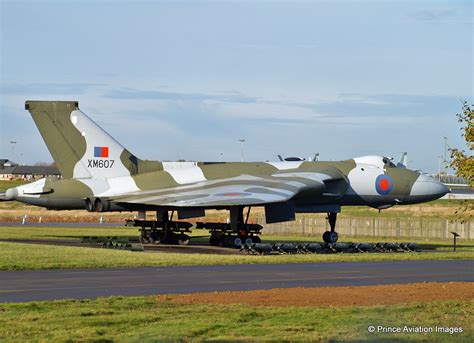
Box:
(0, 0), (474, 172)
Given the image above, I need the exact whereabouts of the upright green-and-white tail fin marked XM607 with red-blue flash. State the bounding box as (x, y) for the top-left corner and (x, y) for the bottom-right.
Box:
(25, 101), (139, 179)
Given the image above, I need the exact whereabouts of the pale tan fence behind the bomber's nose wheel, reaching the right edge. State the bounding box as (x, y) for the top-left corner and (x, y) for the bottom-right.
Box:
(257, 214), (474, 239)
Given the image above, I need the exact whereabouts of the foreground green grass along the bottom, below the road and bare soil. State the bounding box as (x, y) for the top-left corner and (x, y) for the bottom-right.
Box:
(0, 297), (474, 342)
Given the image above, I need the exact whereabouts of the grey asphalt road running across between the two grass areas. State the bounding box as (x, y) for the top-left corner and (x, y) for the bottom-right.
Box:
(0, 260), (474, 302)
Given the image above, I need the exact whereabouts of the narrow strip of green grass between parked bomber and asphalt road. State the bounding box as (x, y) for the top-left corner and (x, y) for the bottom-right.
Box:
(0, 242), (474, 270)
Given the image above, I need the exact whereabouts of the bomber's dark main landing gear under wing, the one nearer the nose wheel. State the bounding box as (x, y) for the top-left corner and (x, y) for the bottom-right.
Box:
(196, 206), (263, 248)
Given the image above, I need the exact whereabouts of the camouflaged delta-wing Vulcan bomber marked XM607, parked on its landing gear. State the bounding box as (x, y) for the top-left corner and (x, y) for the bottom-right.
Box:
(4, 101), (449, 244)
